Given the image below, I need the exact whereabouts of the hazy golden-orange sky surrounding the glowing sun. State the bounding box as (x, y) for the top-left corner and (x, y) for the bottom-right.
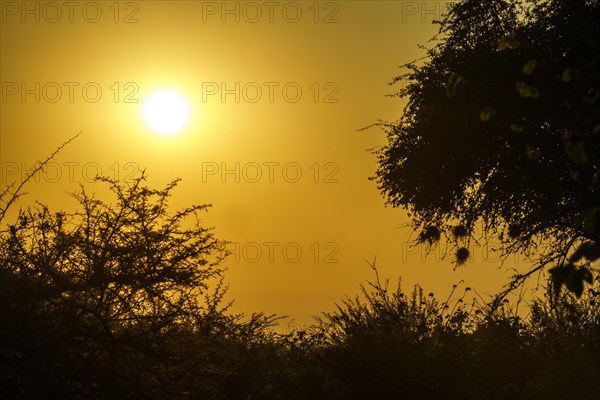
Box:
(0, 1), (536, 323)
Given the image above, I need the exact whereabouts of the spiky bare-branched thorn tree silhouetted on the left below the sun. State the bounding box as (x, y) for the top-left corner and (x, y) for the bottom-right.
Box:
(0, 170), (273, 399)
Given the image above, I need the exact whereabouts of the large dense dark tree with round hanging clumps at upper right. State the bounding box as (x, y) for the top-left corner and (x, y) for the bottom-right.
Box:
(373, 0), (600, 298)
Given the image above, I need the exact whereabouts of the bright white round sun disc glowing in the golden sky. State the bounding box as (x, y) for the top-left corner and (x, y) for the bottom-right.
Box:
(142, 89), (190, 136)
